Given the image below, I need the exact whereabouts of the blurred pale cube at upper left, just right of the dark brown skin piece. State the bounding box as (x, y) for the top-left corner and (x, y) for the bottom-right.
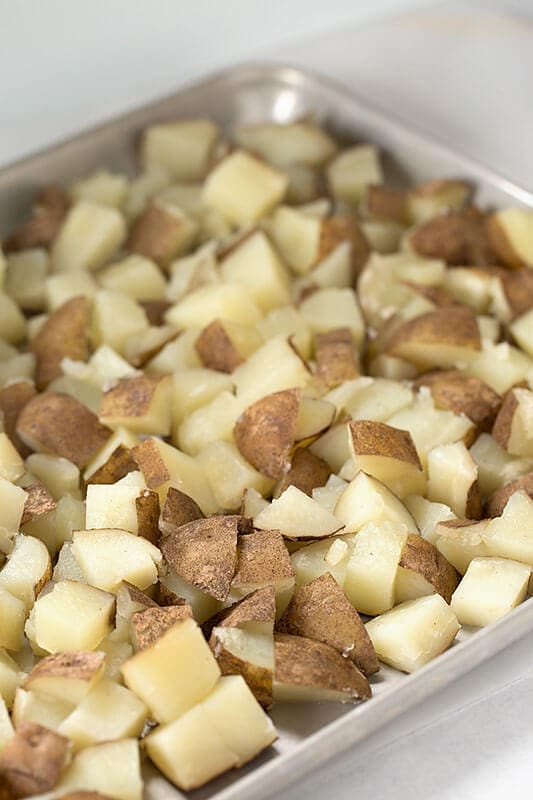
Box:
(50, 200), (126, 272)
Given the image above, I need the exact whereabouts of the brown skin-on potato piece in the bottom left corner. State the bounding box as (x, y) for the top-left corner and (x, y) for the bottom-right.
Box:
(0, 722), (70, 798)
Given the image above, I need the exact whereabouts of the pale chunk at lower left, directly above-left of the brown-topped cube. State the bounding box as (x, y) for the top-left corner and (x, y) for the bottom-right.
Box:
(26, 581), (115, 653)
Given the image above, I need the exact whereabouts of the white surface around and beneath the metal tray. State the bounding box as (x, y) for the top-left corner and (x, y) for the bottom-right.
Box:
(0, 0), (533, 800)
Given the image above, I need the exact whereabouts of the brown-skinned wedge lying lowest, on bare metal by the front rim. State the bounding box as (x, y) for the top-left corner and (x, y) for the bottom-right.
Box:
(274, 633), (372, 703)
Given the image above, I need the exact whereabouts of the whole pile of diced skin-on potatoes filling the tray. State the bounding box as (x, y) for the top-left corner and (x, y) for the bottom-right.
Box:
(0, 114), (533, 800)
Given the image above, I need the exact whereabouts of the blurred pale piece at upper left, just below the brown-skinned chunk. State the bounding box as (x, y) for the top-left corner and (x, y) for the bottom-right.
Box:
(98, 255), (166, 300)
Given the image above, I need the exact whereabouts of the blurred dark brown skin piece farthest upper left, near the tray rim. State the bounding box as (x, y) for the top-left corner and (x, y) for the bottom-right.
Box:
(4, 186), (69, 253)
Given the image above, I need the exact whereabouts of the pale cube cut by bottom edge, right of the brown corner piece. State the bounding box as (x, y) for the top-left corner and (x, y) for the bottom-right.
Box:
(57, 739), (143, 800)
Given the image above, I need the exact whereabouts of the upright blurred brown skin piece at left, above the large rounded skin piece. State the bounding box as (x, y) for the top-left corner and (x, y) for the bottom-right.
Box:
(31, 297), (90, 389)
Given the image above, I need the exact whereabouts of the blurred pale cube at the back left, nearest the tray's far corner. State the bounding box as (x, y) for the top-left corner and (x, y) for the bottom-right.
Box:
(141, 119), (219, 181)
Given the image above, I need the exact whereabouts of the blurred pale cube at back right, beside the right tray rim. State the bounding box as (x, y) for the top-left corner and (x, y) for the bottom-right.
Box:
(326, 144), (383, 205)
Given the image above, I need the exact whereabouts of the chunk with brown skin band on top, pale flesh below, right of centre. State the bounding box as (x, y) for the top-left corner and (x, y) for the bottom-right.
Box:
(348, 420), (426, 499)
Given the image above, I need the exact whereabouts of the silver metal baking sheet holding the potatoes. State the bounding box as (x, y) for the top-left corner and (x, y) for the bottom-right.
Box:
(0, 64), (533, 800)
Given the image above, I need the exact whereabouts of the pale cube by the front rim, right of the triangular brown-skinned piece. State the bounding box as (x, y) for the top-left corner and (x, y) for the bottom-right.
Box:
(366, 594), (461, 672)
